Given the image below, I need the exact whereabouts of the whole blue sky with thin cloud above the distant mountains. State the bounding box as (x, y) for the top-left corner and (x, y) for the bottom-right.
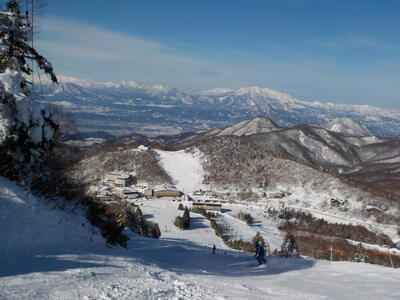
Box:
(36, 0), (400, 109)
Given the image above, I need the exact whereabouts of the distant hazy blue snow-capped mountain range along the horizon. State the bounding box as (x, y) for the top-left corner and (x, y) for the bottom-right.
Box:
(42, 76), (400, 136)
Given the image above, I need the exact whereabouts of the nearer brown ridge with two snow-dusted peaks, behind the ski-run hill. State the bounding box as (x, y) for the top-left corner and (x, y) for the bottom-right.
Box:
(94, 117), (400, 199)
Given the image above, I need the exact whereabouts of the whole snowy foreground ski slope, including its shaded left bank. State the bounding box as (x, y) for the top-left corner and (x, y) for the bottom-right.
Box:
(0, 178), (400, 299)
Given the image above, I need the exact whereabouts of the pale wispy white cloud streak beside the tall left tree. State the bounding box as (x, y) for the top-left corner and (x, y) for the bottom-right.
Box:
(38, 17), (244, 89)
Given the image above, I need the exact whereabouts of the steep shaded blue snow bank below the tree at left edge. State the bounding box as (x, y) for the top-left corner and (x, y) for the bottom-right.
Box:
(0, 177), (104, 258)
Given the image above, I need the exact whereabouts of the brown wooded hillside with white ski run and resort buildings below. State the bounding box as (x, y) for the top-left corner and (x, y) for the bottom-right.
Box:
(60, 135), (400, 265)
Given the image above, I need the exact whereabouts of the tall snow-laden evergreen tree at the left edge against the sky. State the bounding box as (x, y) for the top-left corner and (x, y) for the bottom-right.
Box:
(0, 0), (57, 183)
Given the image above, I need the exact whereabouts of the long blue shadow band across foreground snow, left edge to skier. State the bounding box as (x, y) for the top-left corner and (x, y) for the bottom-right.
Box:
(0, 232), (314, 277)
